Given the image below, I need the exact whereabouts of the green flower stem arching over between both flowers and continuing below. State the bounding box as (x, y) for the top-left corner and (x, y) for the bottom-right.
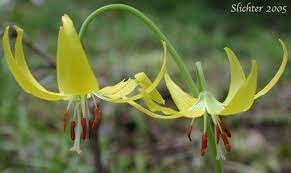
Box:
(79, 4), (223, 173)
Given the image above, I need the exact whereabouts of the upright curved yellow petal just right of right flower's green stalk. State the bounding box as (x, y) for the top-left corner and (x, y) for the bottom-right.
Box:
(224, 47), (246, 104)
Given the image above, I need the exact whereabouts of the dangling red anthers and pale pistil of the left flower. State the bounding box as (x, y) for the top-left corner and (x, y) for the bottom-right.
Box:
(64, 95), (101, 153)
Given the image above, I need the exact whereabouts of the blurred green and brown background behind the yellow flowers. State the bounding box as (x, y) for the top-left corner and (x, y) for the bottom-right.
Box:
(0, 0), (291, 173)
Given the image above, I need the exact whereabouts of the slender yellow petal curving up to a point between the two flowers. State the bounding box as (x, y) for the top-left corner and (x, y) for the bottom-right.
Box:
(95, 42), (167, 103)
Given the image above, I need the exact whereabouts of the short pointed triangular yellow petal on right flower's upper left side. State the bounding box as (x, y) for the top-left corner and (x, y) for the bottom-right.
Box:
(165, 72), (197, 111)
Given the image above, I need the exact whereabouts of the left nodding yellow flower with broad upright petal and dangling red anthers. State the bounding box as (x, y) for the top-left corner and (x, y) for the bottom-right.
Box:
(3, 15), (167, 153)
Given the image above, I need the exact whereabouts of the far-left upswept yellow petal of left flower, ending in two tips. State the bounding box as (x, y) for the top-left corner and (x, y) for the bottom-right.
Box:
(3, 27), (67, 100)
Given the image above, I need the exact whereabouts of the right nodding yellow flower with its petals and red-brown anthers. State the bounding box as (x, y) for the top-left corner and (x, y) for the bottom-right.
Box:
(138, 39), (288, 159)
